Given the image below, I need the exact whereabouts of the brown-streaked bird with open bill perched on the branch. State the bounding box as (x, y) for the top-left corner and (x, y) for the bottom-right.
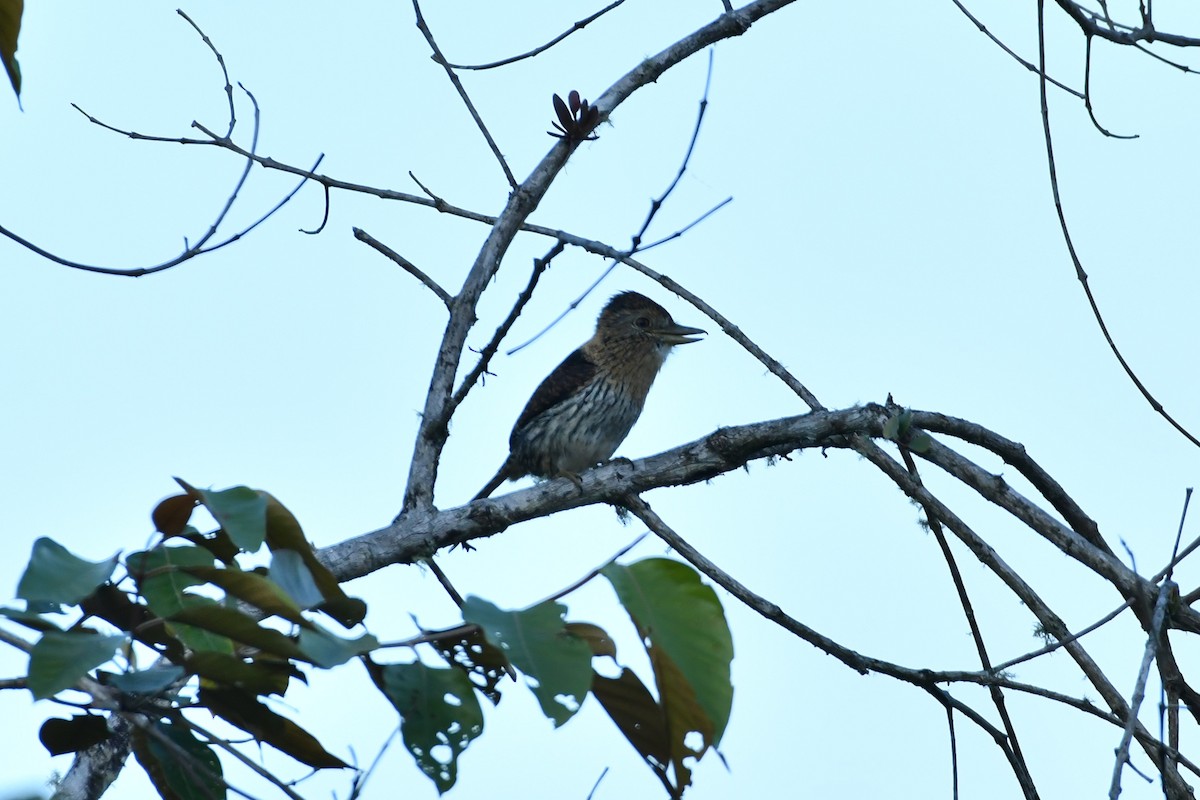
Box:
(474, 291), (704, 500)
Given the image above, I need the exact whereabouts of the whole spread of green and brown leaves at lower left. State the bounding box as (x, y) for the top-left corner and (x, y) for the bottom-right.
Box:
(0, 481), (733, 800)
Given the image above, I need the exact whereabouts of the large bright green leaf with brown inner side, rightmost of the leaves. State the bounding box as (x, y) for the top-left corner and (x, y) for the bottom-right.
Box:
(601, 558), (733, 748)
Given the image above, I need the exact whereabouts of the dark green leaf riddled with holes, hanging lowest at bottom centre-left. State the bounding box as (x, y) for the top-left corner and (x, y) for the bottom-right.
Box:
(371, 662), (484, 794)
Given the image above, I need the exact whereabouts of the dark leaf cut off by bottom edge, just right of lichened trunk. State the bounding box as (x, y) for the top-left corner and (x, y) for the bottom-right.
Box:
(132, 720), (226, 800)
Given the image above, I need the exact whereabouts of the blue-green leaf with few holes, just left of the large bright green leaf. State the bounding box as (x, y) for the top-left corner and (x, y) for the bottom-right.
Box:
(462, 596), (592, 728)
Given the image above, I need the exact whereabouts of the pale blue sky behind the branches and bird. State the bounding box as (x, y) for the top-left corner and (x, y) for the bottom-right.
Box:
(0, 0), (1200, 800)
